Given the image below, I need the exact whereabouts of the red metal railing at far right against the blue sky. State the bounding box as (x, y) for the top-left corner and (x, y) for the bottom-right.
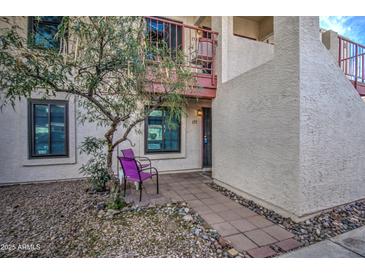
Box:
(338, 36), (365, 96)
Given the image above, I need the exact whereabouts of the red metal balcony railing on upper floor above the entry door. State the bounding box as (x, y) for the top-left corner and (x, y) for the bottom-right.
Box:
(145, 16), (218, 98)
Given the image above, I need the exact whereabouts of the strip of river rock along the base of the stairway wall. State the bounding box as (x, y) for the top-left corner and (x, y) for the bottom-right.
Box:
(207, 182), (365, 246)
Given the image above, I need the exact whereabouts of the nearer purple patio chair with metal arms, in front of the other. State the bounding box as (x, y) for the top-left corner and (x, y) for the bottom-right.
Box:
(118, 157), (159, 201)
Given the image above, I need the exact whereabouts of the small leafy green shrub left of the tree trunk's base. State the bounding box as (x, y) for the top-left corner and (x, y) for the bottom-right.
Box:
(80, 137), (111, 191)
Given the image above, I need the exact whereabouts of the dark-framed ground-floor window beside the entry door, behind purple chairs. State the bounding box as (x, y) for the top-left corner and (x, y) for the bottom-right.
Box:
(145, 108), (181, 153)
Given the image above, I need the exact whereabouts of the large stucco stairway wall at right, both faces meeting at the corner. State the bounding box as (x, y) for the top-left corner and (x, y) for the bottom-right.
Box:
(213, 17), (365, 219)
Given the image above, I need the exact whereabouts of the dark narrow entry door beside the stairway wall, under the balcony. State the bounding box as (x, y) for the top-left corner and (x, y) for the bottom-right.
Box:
(203, 108), (212, 167)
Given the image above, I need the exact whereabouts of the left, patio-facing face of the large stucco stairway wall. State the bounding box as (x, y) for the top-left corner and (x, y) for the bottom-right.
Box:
(213, 18), (299, 216)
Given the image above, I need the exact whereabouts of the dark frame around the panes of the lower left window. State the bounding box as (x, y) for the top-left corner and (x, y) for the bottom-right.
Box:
(28, 99), (69, 159)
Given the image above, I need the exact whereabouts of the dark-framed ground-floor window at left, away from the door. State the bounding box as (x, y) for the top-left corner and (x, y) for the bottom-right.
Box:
(28, 100), (68, 158)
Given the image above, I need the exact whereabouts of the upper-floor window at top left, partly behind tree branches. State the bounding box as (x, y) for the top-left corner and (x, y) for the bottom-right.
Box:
(29, 16), (62, 49)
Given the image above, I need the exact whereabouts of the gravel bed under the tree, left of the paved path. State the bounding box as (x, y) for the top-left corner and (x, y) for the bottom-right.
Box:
(0, 181), (230, 257)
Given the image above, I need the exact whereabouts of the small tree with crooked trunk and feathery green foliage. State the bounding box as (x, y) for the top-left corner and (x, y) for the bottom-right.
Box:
(0, 17), (194, 199)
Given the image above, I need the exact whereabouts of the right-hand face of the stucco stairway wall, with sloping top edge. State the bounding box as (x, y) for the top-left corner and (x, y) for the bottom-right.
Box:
(298, 17), (365, 215)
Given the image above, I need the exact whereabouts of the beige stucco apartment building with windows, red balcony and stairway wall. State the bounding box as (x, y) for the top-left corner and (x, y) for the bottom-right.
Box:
(0, 16), (365, 219)
